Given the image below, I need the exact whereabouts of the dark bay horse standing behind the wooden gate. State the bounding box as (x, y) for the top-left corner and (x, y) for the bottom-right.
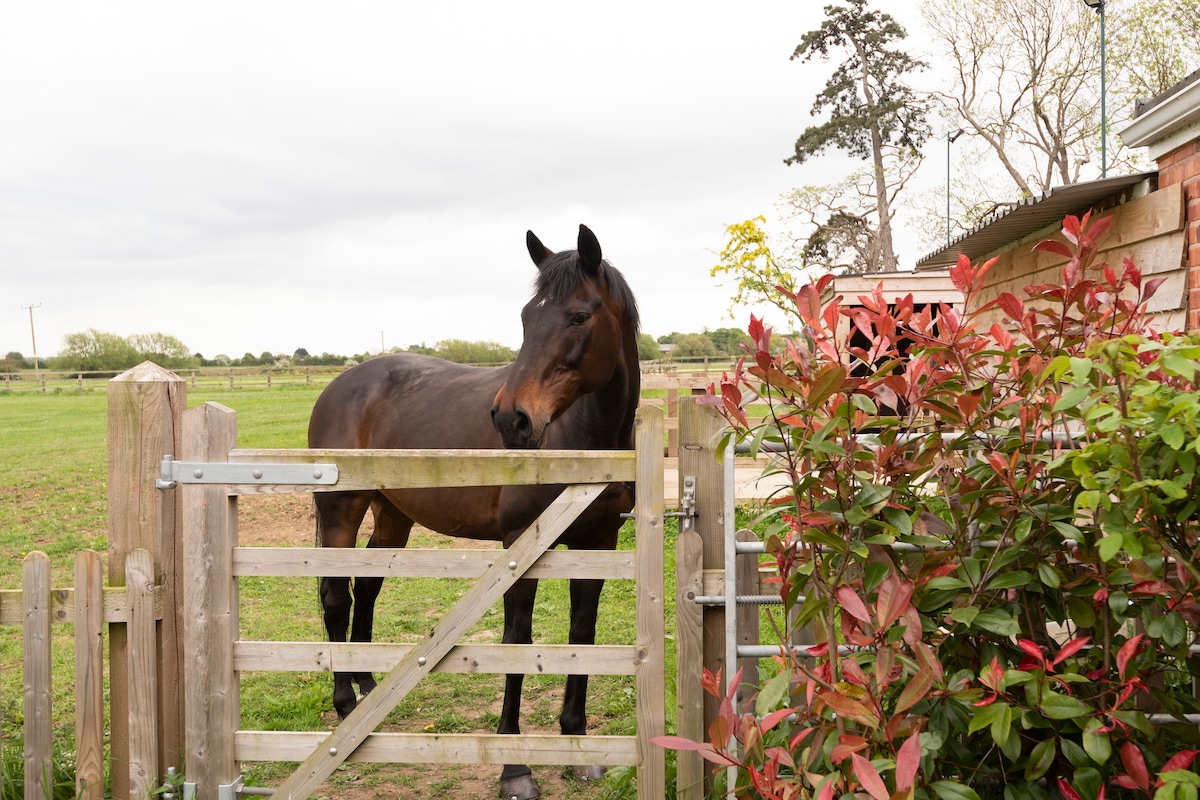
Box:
(308, 225), (641, 800)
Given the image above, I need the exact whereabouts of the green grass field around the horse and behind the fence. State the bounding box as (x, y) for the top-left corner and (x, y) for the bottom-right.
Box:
(0, 386), (674, 798)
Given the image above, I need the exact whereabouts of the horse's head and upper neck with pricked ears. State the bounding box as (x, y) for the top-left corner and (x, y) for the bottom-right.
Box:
(492, 225), (637, 449)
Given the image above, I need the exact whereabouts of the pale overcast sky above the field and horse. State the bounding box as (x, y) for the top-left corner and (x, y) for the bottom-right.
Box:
(0, 0), (944, 357)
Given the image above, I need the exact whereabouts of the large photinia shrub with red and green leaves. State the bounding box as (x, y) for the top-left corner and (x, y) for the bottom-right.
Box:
(659, 216), (1200, 800)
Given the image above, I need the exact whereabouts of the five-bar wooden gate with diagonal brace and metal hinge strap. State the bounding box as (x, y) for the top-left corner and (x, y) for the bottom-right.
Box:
(177, 403), (665, 800)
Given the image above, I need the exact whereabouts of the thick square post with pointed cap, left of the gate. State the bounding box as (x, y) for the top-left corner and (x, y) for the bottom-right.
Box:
(108, 361), (187, 798)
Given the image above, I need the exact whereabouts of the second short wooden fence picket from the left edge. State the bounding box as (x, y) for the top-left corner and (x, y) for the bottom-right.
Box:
(74, 551), (104, 800)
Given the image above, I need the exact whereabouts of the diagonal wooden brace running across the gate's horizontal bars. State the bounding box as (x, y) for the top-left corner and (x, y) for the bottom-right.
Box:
(274, 483), (605, 800)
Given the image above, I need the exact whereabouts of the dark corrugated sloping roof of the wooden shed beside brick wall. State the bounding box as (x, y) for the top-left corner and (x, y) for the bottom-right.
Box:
(917, 172), (1157, 270)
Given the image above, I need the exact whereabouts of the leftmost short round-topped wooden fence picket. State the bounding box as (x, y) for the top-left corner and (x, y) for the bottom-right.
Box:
(20, 551), (54, 800)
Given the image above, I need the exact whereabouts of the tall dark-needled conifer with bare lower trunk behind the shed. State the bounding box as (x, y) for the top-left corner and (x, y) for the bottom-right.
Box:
(785, 0), (929, 272)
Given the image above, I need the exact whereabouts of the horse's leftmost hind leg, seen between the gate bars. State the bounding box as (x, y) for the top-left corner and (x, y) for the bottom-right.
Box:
(313, 492), (374, 717)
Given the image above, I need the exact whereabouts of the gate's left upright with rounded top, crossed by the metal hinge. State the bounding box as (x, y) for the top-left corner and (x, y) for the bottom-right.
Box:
(175, 403), (241, 800)
